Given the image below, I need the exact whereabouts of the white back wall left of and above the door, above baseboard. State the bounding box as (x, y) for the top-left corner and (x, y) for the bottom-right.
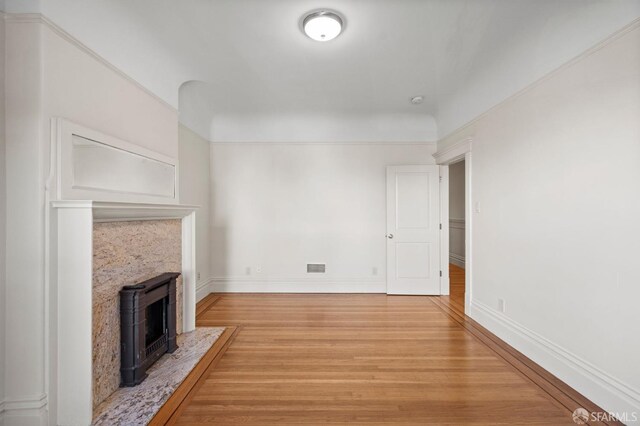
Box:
(211, 143), (435, 292)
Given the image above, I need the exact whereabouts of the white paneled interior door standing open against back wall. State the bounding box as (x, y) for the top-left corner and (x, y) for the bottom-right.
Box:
(387, 166), (440, 295)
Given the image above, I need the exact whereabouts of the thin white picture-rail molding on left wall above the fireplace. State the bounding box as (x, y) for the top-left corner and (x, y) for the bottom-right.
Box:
(3, 13), (178, 114)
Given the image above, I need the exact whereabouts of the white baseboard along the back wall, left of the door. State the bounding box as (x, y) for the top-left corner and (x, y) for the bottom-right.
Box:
(212, 278), (387, 293)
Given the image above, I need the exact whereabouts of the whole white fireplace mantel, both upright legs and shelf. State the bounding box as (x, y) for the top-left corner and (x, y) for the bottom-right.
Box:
(47, 200), (197, 425)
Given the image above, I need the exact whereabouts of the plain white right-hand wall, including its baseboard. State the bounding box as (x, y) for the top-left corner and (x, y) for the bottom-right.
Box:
(439, 23), (640, 420)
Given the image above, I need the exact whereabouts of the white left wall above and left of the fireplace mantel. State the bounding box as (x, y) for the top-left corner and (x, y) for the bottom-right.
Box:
(5, 16), (178, 425)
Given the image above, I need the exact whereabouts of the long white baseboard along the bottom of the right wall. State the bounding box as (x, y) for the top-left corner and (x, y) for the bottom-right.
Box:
(469, 300), (640, 424)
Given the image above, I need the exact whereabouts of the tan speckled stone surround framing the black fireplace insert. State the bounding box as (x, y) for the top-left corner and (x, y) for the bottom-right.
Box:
(92, 219), (183, 408)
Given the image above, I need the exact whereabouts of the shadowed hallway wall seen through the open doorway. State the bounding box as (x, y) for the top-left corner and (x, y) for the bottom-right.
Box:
(449, 161), (465, 268)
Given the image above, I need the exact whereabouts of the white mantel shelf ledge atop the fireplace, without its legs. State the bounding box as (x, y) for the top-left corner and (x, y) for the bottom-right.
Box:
(51, 200), (199, 222)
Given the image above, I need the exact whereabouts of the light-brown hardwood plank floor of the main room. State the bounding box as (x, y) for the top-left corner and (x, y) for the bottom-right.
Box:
(168, 292), (616, 425)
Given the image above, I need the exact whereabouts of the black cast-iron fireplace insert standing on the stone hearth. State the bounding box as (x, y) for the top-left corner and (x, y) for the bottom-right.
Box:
(120, 272), (180, 386)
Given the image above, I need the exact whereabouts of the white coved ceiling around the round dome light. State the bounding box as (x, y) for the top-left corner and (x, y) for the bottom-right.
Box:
(6, 0), (640, 140)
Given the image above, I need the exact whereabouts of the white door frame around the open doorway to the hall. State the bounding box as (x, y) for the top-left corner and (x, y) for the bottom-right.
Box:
(433, 137), (473, 315)
